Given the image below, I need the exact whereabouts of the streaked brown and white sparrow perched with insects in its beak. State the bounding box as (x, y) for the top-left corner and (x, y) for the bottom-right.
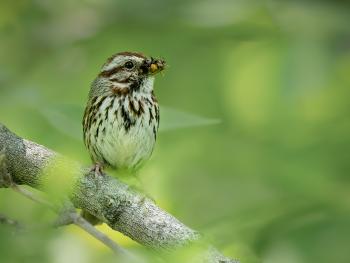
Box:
(83, 52), (165, 173)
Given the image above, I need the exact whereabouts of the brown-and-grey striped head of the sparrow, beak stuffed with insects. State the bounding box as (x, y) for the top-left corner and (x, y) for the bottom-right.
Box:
(90, 52), (165, 97)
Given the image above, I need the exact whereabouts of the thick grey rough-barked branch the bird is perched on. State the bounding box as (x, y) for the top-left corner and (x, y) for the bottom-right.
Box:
(0, 123), (236, 263)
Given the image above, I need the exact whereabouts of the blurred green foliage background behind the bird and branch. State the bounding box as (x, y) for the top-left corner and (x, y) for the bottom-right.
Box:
(0, 0), (350, 263)
